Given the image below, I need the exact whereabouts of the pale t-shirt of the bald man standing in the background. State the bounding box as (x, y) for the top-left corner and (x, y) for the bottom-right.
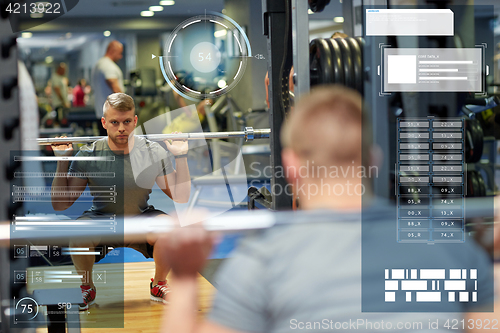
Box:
(92, 57), (125, 118)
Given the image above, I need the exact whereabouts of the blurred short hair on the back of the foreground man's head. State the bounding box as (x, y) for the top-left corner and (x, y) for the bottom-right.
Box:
(281, 85), (370, 166)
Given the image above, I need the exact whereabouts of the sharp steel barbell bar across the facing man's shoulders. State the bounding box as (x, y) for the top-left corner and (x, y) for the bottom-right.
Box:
(36, 127), (271, 145)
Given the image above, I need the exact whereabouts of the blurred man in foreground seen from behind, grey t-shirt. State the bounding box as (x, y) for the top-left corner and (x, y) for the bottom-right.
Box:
(157, 86), (493, 333)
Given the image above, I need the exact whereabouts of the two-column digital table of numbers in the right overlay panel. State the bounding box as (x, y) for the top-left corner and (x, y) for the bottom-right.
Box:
(396, 117), (466, 243)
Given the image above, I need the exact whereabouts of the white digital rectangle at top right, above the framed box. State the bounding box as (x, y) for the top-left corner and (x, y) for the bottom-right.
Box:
(365, 9), (454, 36)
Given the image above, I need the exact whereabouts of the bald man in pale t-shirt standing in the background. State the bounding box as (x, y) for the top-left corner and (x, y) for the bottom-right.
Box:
(91, 40), (125, 119)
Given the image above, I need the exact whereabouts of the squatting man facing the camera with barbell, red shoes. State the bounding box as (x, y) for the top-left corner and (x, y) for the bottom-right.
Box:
(51, 93), (191, 310)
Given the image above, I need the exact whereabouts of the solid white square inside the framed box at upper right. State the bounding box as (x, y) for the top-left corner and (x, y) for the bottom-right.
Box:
(387, 55), (417, 84)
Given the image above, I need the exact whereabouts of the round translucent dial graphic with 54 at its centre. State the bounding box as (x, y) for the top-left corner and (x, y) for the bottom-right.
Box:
(160, 13), (252, 101)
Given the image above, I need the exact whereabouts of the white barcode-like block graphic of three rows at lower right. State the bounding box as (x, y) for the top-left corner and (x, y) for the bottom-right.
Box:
(385, 268), (477, 303)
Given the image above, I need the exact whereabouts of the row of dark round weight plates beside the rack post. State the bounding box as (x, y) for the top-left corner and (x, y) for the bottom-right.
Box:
(309, 37), (364, 94)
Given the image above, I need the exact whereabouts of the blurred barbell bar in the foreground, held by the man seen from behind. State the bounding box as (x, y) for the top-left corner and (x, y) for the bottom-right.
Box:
(0, 198), (496, 247)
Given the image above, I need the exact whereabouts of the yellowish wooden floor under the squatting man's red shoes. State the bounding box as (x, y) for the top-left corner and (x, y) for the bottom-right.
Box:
(28, 262), (215, 333)
